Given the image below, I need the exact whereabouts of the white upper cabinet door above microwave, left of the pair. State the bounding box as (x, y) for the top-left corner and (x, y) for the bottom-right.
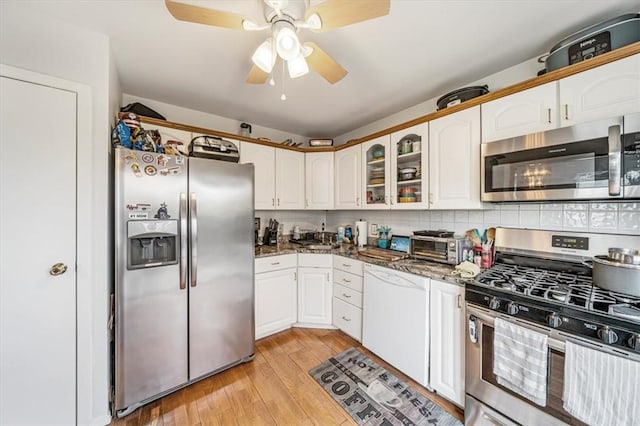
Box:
(482, 81), (558, 142)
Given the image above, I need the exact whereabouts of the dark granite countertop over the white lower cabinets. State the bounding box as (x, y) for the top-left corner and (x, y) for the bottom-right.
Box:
(255, 243), (473, 286)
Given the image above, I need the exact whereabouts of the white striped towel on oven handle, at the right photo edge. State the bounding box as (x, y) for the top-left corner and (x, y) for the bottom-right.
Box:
(562, 340), (640, 426)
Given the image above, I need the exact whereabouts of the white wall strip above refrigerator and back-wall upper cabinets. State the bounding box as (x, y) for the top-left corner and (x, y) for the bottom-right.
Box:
(122, 93), (308, 145)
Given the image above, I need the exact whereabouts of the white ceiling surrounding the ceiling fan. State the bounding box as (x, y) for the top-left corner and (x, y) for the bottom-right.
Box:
(10, 0), (639, 137)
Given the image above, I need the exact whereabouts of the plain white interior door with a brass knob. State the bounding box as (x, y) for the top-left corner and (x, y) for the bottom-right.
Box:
(0, 77), (76, 425)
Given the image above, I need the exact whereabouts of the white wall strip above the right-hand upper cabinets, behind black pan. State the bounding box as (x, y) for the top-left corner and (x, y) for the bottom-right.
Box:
(334, 58), (544, 145)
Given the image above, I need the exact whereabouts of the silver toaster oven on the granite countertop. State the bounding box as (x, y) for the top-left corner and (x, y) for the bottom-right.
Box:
(410, 230), (465, 265)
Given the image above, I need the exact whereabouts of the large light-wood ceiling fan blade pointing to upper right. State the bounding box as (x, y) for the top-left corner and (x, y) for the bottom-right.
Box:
(305, 0), (391, 31)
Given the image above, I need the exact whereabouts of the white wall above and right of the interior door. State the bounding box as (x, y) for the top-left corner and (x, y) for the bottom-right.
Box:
(0, 1), (112, 424)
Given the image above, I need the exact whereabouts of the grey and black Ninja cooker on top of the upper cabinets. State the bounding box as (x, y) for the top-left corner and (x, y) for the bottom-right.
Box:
(540, 13), (640, 71)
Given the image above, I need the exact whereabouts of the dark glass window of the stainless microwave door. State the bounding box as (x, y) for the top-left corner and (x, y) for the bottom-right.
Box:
(484, 138), (609, 192)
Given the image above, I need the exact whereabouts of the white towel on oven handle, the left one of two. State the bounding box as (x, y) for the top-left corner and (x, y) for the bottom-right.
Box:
(493, 318), (549, 407)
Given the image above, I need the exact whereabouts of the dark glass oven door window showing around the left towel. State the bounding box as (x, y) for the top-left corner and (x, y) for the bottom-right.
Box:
(481, 323), (584, 425)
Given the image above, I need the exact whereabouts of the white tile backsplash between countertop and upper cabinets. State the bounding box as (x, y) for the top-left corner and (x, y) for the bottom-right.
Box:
(256, 202), (640, 240)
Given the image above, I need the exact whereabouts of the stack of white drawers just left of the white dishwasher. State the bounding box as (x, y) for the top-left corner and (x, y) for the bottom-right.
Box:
(333, 256), (363, 341)
